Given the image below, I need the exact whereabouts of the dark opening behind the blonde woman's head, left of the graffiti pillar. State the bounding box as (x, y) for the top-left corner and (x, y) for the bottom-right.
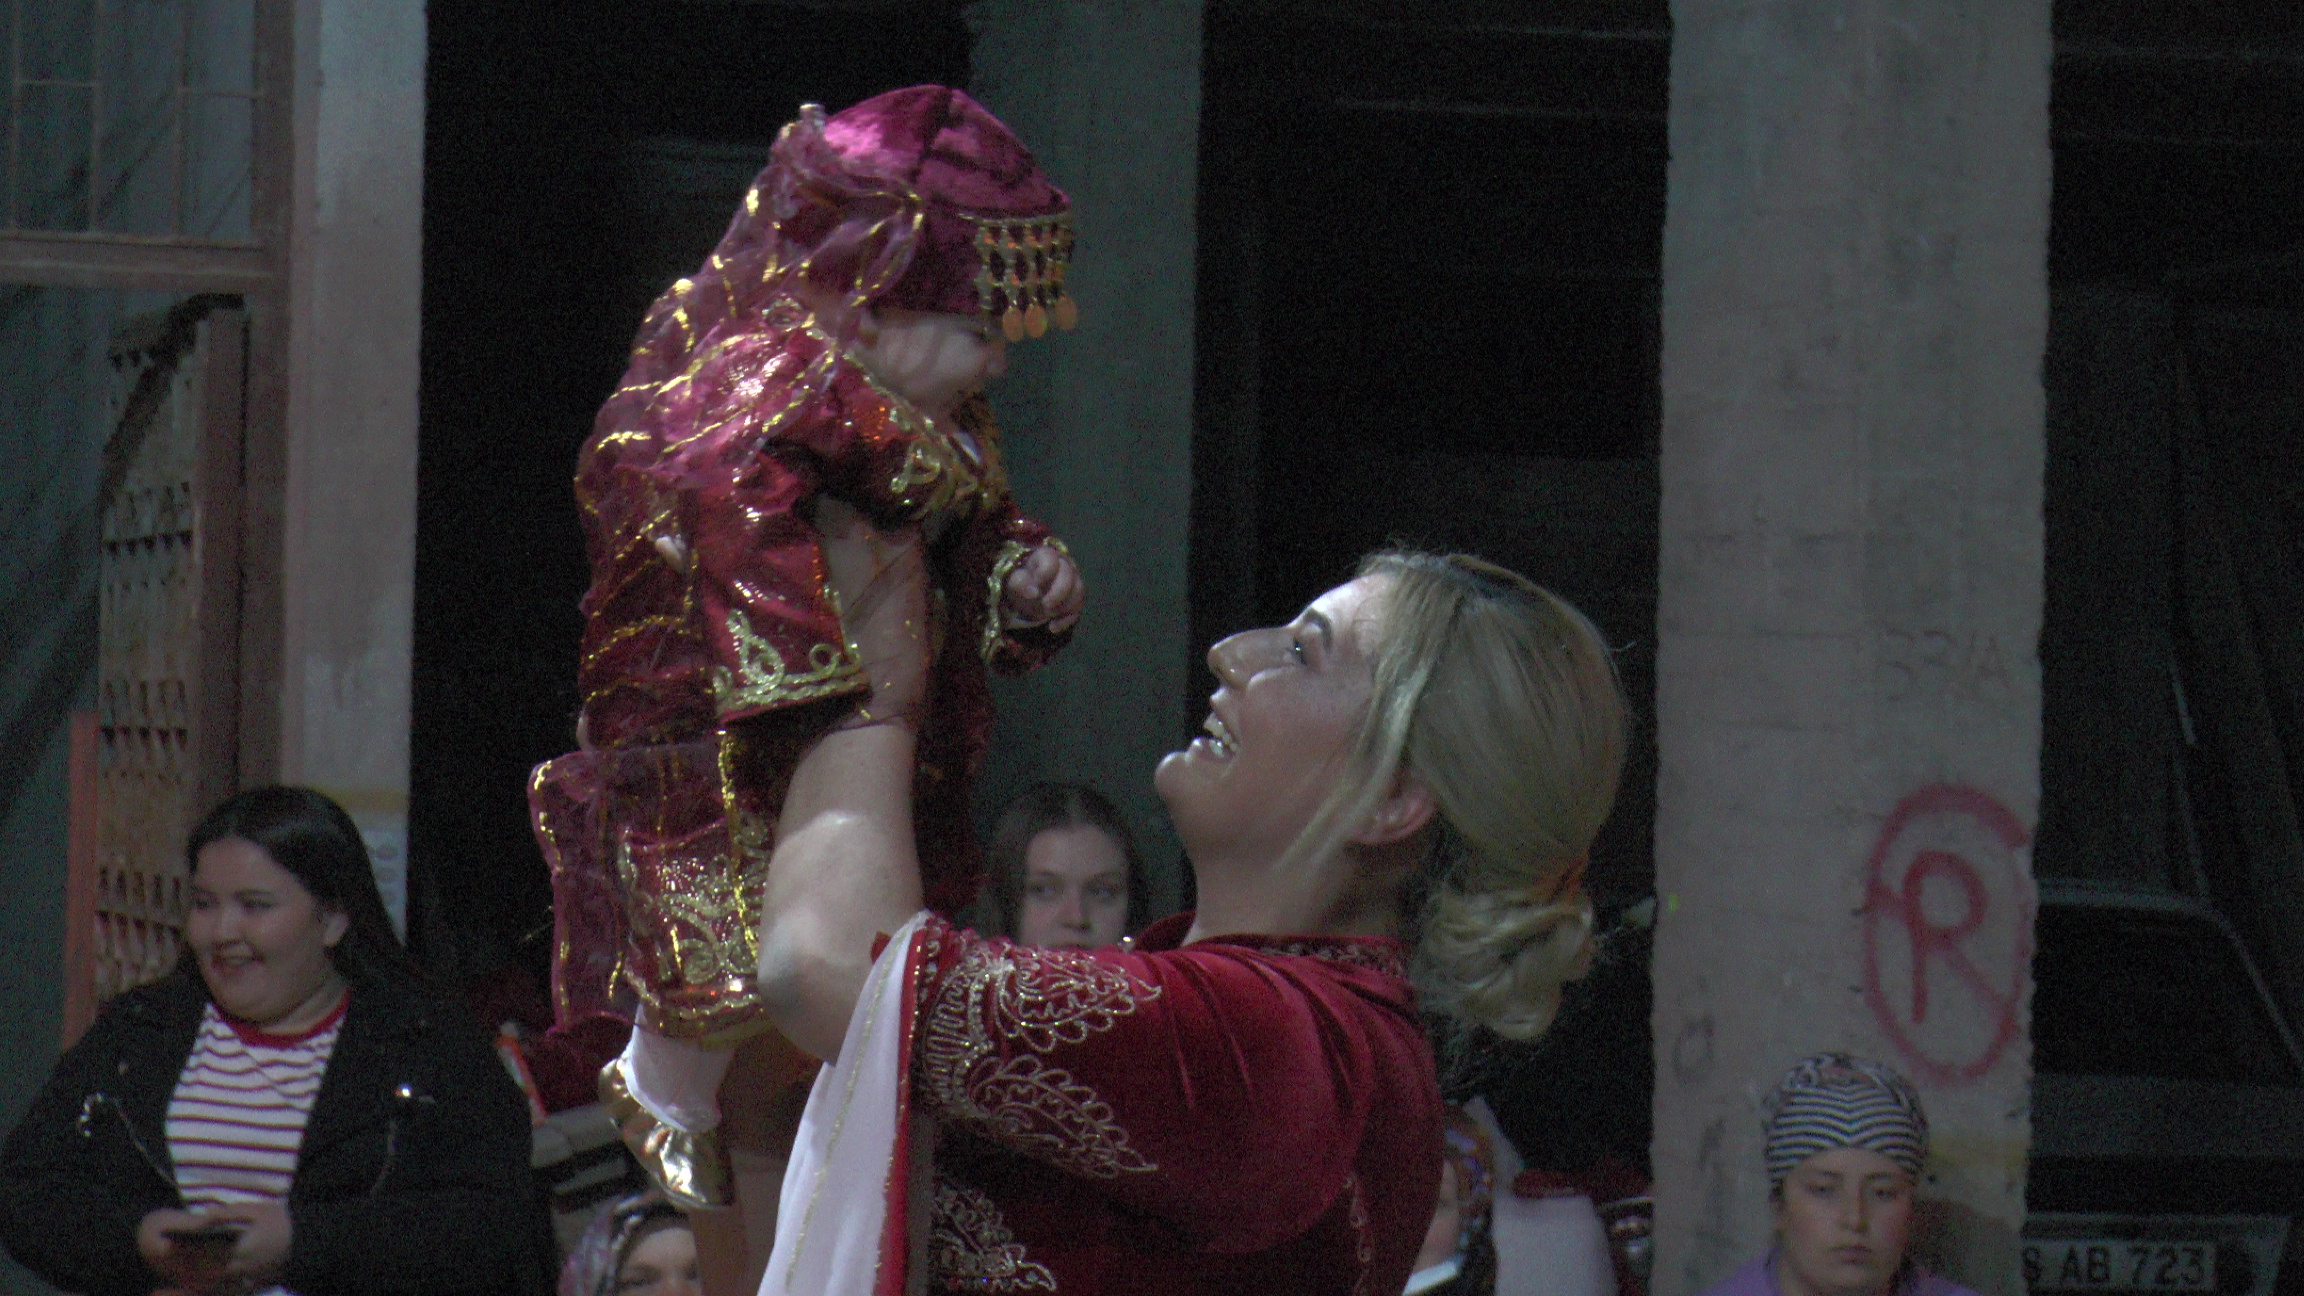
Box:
(1191, 0), (1670, 1171)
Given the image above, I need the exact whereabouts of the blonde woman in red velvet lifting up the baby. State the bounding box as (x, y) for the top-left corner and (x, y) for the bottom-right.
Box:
(640, 509), (1627, 1296)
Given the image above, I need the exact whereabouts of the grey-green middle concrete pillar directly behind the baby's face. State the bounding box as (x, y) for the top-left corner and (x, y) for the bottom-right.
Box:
(970, 0), (1205, 904)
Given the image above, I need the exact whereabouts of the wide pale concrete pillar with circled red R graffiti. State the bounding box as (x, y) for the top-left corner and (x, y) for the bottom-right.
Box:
(1654, 0), (2051, 1296)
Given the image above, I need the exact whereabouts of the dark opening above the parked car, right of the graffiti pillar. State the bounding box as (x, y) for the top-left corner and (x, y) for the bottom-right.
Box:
(2034, 0), (2304, 1000)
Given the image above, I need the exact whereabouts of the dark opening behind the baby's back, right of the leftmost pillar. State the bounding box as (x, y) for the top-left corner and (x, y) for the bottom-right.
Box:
(408, 0), (968, 978)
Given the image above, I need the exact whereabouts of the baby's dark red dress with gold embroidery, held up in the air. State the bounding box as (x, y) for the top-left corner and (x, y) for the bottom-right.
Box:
(530, 300), (1062, 1038)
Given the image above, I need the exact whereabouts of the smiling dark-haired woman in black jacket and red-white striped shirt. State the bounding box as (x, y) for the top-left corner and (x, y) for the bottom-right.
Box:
(0, 786), (553, 1296)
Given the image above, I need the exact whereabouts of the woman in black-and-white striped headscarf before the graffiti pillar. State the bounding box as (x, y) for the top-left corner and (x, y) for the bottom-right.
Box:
(1703, 1054), (1975, 1296)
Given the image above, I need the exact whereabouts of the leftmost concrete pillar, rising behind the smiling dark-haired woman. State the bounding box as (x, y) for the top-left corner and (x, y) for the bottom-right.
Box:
(276, 0), (428, 920)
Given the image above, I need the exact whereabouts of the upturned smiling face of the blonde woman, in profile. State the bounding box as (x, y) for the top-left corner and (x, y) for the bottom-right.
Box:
(1154, 577), (1389, 867)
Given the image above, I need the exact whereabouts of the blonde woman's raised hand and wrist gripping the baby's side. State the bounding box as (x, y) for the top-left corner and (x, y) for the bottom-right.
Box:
(816, 498), (935, 719)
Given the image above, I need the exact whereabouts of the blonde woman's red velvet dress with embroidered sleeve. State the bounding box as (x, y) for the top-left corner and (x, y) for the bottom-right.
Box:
(910, 916), (1442, 1296)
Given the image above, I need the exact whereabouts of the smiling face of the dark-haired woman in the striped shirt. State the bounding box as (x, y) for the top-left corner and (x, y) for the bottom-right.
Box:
(184, 837), (348, 1026)
